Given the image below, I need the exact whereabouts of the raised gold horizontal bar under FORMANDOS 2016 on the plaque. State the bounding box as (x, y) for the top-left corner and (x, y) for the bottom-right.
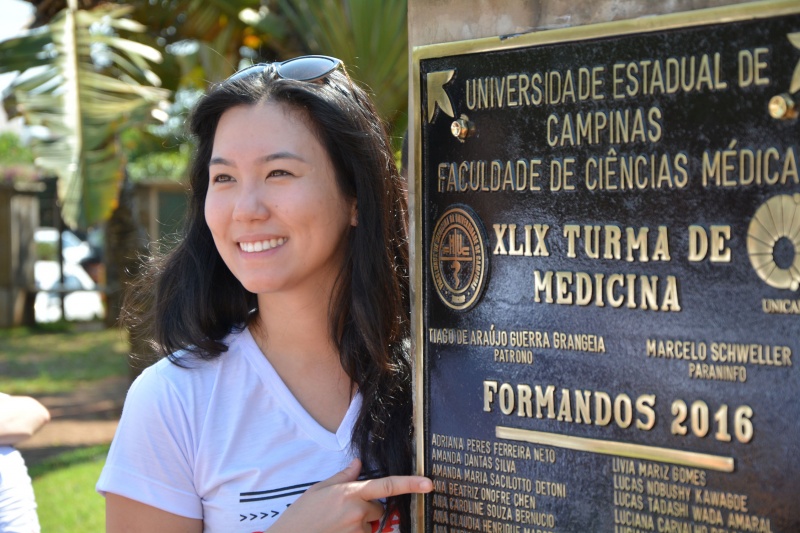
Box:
(495, 426), (734, 473)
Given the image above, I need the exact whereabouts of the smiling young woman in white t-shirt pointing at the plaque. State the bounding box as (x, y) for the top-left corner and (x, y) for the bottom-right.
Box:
(98, 56), (432, 533)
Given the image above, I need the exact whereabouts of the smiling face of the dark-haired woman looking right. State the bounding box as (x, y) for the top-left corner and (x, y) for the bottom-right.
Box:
(205, 103), (356, 294)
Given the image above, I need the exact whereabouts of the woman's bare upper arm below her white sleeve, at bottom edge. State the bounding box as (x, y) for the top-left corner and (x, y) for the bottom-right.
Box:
(106, 492), (203, 533)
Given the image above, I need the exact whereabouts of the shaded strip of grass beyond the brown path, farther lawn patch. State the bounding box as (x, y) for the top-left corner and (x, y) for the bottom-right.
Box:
(0, 326), (128, 395)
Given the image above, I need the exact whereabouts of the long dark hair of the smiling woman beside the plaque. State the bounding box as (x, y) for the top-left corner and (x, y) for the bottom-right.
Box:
(126, 67), (412, 531)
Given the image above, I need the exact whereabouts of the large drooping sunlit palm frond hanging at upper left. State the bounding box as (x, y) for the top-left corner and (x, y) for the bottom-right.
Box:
(0, 4), (169, 228)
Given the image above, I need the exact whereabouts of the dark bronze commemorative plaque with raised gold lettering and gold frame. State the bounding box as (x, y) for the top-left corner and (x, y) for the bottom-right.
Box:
(412, 1), (800, 533)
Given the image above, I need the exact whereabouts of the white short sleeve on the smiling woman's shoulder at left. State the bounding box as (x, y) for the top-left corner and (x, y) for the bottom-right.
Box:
(96, 362), (203, 519)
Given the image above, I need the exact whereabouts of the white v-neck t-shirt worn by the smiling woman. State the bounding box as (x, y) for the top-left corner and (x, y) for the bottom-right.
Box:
(97, 329), (361, 533)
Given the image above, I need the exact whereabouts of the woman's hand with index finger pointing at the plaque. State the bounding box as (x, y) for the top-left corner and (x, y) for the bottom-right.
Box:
(269, 459), (433, 533)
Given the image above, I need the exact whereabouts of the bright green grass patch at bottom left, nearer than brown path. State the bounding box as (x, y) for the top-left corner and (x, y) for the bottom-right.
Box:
(30, 446), (108, 533)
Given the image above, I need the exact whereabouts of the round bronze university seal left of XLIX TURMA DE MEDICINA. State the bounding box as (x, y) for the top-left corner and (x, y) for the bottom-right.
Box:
(430, 206), (488, 311)
